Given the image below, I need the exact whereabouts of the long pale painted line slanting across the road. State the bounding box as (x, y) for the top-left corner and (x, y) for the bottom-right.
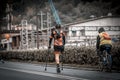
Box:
(0, 67), (89, 80)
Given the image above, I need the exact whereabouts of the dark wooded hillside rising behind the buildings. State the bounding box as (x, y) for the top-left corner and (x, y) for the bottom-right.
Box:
(1, 0), (120, 24)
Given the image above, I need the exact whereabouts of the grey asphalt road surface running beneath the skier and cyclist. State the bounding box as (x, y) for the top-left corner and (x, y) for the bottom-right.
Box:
(0, 62), (120, 80)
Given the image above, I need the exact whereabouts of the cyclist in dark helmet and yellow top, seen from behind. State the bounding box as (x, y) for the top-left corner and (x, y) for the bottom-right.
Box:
(96, 27), (112, 60)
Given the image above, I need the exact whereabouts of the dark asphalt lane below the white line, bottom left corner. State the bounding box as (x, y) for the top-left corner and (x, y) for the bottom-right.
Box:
(0, 69), (66, 80)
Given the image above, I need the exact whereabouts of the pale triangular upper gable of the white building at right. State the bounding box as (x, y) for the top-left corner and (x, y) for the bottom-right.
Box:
(70, 17), (120, 26)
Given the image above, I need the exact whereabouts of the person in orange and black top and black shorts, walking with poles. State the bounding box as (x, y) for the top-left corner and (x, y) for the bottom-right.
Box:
(48, 25), (65, 73)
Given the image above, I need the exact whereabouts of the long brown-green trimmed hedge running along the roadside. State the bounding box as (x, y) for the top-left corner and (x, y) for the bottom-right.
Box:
(0, 45), (120, 66)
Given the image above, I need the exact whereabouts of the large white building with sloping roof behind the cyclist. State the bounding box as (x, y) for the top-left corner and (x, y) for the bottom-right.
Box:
(65, 16), (120, 45)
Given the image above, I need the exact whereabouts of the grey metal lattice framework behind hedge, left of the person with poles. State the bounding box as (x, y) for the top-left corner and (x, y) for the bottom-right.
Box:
(20, 11), (53, 50)
